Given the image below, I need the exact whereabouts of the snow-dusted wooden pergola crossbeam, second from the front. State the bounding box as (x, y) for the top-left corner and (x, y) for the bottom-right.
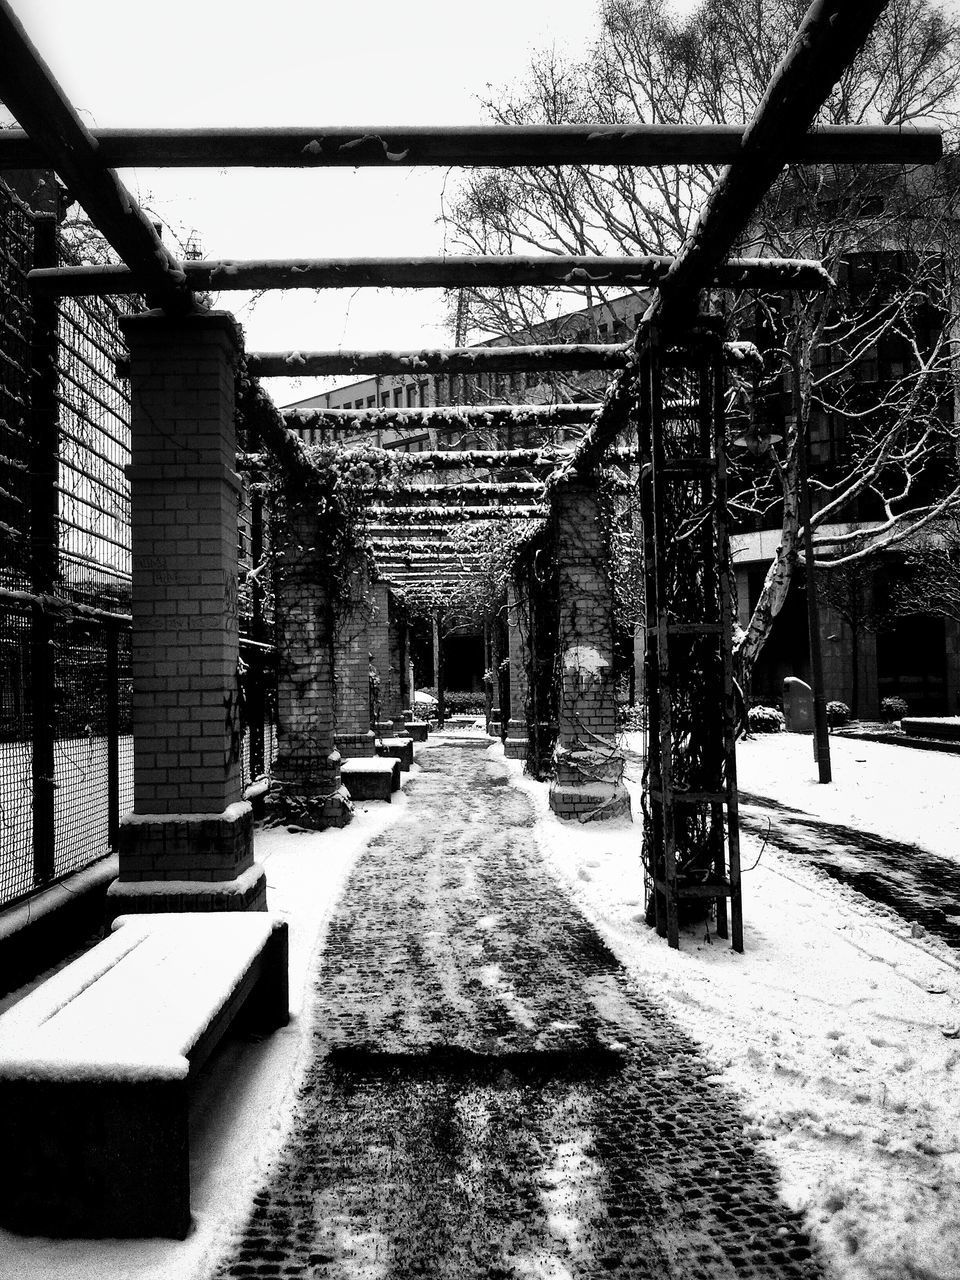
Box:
(28, 253), (832, 297)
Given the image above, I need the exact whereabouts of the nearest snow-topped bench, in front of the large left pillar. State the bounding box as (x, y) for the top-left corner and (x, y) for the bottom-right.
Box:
(0, 911), (289, 1239)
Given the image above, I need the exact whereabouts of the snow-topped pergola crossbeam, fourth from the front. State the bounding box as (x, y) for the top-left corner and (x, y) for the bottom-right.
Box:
(283, 403), (599, 434)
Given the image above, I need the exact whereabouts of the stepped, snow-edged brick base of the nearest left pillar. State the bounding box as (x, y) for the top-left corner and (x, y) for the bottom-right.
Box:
(108, 800), (266, 920)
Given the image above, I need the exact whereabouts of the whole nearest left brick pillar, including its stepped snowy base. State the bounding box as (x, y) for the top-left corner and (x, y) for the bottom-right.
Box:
(110, 312), (266, 915)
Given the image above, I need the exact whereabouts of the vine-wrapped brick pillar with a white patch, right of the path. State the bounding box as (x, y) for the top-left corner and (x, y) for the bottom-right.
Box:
(550, 481), (630, 820)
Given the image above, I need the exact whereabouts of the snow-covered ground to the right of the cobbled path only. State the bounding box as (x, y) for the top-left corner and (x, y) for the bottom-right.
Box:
(514, 735), (960, 1280)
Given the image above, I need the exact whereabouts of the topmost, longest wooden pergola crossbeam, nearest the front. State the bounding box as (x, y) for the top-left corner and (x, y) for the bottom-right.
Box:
(0, 124), (941, 169)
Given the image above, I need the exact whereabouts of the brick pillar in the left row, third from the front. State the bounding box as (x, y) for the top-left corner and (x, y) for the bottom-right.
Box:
(333, 563), (376, 759)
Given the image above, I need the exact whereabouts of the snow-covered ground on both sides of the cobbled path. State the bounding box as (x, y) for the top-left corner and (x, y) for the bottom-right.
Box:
(0, 727), (960, 1280)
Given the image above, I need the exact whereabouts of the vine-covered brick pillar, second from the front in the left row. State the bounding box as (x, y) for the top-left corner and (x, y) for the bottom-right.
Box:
(269, 509), (353, 829)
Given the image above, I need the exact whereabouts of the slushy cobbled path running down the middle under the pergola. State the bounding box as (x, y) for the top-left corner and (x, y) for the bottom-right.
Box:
(218, 740), (820, 1280)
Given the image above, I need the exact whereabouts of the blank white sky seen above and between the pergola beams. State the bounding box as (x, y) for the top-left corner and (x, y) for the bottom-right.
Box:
(12, 0), (955, 403)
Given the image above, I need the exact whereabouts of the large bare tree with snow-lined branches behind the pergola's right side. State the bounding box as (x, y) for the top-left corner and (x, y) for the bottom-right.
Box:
(445, 0), (960, 682)
